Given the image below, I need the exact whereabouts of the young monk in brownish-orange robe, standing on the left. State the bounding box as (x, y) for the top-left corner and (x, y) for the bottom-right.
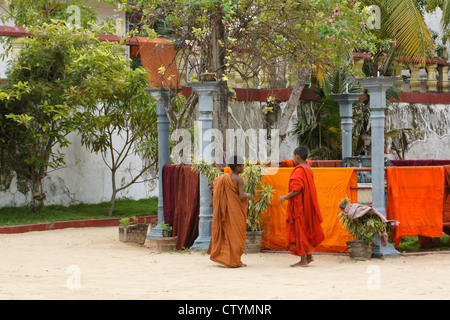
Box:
(208, 156), (251, 268)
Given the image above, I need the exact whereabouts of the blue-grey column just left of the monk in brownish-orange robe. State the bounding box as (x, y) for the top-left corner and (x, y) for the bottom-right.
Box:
(189, 82), (219, 250)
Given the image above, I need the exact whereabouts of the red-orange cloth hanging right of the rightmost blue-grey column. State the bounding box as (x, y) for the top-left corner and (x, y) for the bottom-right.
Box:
(386, 166), (445, 245)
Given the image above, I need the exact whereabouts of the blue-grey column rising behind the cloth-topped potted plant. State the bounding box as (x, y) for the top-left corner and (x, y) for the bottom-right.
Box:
(357, 77), (400, 258)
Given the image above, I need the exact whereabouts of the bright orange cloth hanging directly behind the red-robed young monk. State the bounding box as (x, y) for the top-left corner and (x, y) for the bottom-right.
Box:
(262, 168), (358, 252)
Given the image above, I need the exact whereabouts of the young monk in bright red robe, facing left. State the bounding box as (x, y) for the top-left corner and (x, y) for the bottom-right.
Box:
(279, 147), (325, 267)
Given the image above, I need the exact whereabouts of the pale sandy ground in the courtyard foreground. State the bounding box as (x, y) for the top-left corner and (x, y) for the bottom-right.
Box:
(0, 227), (450, 300)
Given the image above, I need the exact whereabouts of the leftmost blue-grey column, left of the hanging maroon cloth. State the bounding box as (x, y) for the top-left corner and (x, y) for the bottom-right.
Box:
(146, 89), (170, 240)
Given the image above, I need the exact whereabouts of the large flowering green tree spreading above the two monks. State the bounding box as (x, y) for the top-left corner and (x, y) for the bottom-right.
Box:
(124, 0), (373, 146)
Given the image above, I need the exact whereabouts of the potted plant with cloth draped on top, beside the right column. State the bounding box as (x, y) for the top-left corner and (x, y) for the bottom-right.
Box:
(339, 197), (398, 261)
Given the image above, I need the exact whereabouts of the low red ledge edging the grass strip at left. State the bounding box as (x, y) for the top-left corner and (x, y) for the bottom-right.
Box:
(0, 215), (158, 233)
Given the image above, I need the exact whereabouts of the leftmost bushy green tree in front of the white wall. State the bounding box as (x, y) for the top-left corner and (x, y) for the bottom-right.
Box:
(1, 23), (90, 211)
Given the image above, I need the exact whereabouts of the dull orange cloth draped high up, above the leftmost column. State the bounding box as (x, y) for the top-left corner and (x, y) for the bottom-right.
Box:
(132, 37), (180, 88)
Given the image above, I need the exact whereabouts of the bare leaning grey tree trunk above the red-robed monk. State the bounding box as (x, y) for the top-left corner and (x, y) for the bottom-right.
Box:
(278, 68), (311, 144)
